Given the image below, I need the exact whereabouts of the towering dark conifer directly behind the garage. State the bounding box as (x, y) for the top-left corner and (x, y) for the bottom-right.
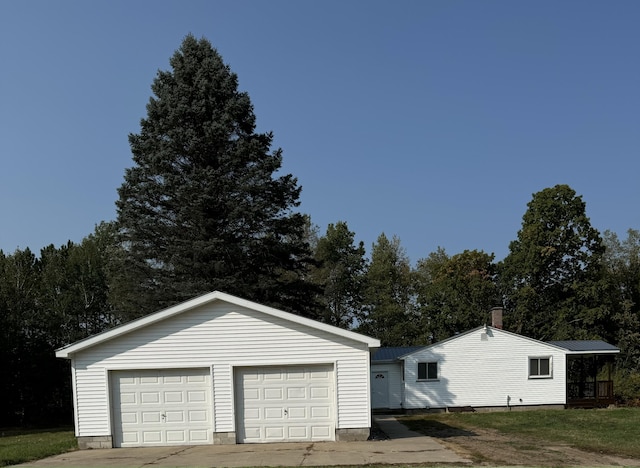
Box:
(117, 35), (311, 316)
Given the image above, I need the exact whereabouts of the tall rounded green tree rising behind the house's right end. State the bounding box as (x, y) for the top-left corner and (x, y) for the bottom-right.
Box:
(500, 185), (607, 340)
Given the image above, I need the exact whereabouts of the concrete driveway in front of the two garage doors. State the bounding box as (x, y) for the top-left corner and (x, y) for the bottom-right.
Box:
(13, 416), (470, 468)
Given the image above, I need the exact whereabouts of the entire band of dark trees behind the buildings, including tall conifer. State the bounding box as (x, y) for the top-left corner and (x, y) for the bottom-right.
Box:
(0, 35), (640, 427)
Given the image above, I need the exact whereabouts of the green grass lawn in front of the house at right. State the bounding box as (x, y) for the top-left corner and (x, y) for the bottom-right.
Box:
(401, 408), (640, 458)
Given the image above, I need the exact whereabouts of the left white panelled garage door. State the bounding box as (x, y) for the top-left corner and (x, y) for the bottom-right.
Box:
(111, 369), (212, 447)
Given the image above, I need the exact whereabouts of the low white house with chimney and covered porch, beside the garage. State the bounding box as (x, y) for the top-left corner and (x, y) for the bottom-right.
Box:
(371, 326), (619, 410)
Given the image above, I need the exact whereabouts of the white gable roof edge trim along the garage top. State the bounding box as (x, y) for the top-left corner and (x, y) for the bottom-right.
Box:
(56, 291), (380, 359)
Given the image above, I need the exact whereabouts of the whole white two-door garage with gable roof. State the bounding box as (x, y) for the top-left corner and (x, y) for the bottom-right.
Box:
(56, 291), (380, 448)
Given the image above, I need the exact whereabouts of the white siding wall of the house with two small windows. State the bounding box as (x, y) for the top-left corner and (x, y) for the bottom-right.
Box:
(405, 328), (566, 409)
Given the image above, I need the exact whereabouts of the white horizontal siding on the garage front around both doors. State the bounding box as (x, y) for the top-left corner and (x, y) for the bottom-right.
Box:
(74, 301), (370, 436)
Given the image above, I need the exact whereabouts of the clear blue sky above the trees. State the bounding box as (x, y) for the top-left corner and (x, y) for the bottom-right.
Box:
(0, 0), (640, 262)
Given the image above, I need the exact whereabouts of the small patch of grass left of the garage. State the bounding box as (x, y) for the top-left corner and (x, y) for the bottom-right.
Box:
(0, 428), (78, 466)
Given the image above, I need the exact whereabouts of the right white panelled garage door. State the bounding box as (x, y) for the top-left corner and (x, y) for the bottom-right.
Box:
(236, 365), (335, 443)
